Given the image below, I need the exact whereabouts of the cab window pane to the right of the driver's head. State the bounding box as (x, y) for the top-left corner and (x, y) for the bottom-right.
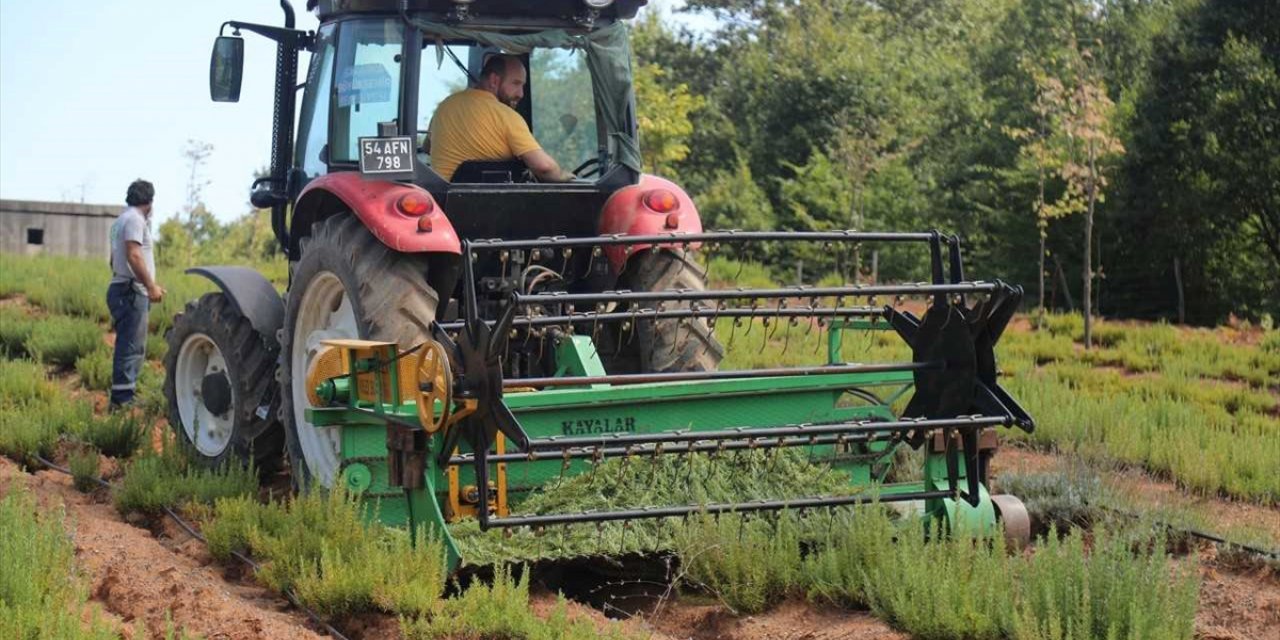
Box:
(529, 49), (599, 177)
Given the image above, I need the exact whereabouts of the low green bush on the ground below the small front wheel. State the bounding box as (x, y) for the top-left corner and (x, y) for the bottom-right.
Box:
(113, 444), (257, 516)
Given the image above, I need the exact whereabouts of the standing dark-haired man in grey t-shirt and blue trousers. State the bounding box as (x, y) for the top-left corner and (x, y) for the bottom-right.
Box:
(106, 179), (164, 410)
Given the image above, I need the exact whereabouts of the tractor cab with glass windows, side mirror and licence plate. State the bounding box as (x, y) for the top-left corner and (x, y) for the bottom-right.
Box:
(210, 0), (646, 257)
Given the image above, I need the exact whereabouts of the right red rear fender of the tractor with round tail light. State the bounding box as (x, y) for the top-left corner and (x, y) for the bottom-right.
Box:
(599, 174), (703, 273)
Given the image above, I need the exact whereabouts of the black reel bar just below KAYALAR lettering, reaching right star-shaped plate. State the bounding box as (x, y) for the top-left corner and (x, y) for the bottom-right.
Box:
(509, 416), (1011, 449)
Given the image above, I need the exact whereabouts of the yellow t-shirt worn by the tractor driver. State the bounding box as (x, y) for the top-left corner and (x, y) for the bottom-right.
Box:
(428, 88), (541, 180)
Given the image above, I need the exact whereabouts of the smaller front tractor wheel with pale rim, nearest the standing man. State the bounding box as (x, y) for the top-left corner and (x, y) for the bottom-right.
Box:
(164, 292), (284, 475)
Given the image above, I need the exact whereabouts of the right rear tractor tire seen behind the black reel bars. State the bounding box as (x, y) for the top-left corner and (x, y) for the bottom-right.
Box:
(604, 248), (724, 374)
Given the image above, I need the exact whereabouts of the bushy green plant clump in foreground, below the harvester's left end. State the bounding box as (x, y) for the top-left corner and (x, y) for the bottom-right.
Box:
(205, 490), (444, 616)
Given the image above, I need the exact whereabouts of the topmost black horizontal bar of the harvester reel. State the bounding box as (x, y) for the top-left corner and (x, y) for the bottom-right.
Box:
(468, 230), (946, 251)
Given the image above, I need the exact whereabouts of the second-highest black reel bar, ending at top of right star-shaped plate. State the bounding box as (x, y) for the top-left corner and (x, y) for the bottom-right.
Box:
(511, 282), (1000, 305)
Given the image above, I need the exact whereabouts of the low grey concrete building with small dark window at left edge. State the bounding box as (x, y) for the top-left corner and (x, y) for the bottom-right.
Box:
(0, 200), (124, 260)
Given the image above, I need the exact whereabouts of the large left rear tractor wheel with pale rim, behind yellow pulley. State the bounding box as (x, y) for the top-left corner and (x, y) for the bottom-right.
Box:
(280, 214), (439, 490)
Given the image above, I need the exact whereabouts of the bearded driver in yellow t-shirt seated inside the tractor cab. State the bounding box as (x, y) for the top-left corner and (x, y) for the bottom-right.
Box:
(429, 55), (573, 182)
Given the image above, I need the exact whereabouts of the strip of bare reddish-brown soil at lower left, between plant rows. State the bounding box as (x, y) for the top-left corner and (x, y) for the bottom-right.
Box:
(0, 458), (323, 640)
